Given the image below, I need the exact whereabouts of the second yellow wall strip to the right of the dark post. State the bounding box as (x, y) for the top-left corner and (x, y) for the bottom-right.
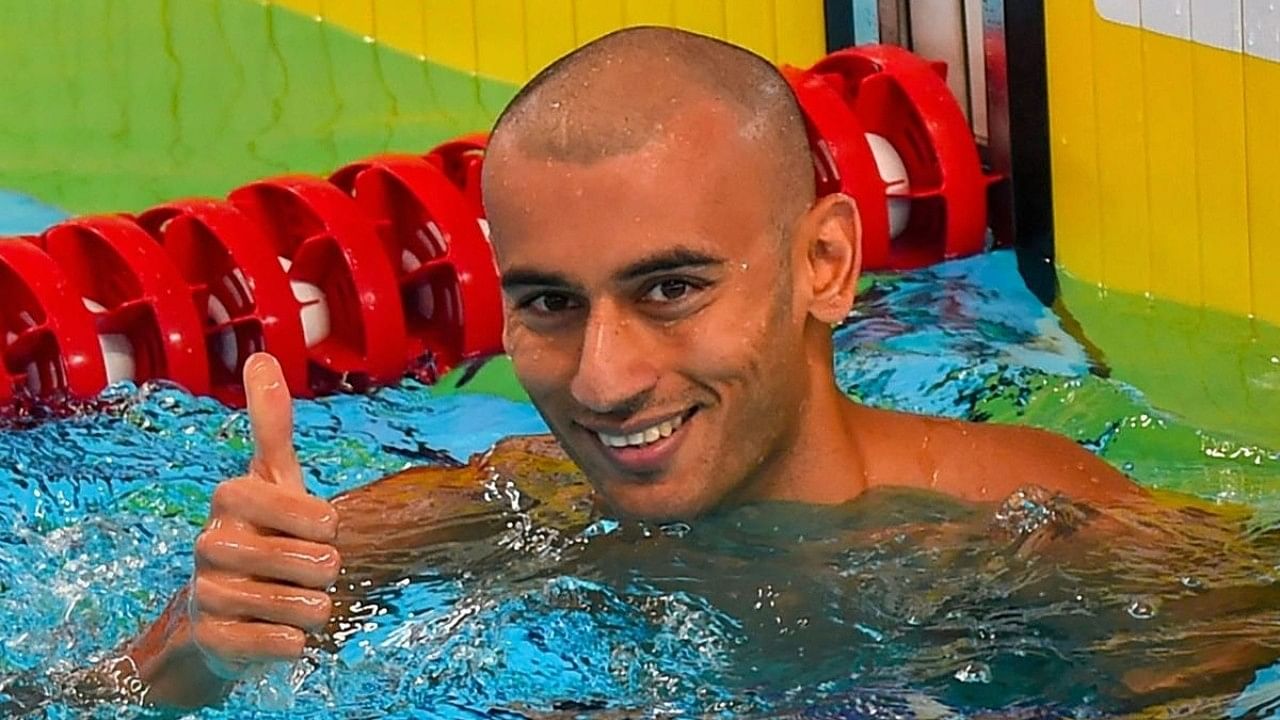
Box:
(1093, 9), (1151, 293)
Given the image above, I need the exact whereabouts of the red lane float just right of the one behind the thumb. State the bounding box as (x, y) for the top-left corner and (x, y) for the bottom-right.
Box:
(229, 176), (407, 389)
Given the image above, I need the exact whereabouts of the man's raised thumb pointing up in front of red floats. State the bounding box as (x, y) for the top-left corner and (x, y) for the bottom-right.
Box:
(244, 352), (306, 492)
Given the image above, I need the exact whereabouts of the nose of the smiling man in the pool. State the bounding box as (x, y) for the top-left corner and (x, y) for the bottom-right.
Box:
(570, 302), (658, 415)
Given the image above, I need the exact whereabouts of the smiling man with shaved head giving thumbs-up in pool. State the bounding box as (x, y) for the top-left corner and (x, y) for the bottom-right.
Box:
(107, 23), (1259, 706)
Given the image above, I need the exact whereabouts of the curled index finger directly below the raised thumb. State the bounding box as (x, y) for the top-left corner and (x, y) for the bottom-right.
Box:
(211, 478), (338, 543)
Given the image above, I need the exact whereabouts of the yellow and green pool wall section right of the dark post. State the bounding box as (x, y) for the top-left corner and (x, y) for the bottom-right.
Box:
(1044, 0), (1280, 443)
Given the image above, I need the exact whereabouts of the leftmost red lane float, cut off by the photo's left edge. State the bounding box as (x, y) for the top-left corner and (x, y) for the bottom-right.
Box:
(0, 238), (106, 400)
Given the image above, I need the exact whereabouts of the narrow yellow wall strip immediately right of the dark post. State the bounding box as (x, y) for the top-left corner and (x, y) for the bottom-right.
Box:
(1044, 1), (1102, 283)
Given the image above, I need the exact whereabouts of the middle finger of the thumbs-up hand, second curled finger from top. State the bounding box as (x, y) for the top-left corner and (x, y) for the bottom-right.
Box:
(196, 530), (342, 589)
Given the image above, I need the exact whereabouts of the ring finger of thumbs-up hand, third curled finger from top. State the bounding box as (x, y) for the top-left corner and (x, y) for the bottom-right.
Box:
(192, 573), (333, 630)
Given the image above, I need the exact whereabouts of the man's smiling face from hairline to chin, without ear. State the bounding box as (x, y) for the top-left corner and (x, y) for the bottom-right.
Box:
(486, 104), (824, 519)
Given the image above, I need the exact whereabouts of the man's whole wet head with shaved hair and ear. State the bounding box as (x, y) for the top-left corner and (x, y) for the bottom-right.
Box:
(484, 28), (856, 519)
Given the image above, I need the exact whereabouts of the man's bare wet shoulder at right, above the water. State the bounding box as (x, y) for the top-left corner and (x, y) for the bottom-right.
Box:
(860, 413), (1143, 502)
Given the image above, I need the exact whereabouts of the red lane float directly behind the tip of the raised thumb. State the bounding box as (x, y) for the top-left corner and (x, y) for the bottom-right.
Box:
(137, 200), (311, 405)
